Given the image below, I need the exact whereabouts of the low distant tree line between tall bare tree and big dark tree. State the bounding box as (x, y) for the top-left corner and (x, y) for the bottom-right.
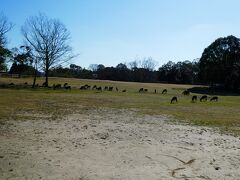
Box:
(46, 58), (199, 84)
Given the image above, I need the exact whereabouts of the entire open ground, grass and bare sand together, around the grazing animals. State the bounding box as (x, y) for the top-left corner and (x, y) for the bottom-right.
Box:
(0, 78), (240, 179)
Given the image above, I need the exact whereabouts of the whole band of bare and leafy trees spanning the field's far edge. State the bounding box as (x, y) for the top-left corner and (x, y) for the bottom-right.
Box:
(0, 14), (240, 91)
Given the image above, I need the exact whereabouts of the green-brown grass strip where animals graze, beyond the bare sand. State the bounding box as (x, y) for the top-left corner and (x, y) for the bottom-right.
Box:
(0, 78), (240, 135)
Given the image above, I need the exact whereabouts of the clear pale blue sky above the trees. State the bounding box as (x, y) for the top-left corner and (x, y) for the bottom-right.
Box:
(0, 0), (240, 68)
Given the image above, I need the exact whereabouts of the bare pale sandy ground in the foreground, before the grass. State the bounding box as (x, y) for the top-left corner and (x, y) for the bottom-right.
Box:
(0, 109), (240, 180)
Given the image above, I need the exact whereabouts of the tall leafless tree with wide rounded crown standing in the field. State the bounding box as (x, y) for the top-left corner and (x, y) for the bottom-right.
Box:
(22, 14), (73, 87)
